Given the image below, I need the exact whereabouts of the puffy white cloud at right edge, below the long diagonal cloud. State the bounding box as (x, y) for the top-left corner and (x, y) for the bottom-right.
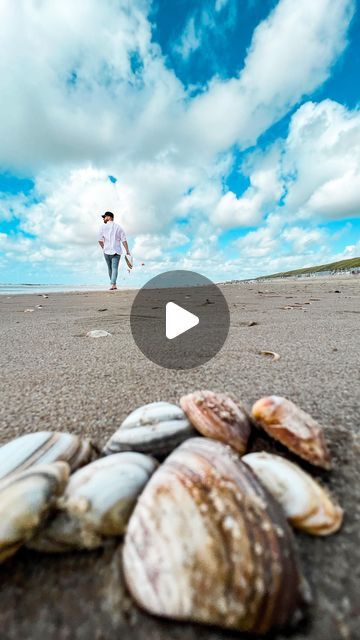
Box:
(218, 100), (360, 227)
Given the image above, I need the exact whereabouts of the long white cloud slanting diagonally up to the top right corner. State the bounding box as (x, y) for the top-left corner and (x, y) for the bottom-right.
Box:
(185, 0), (354, 153)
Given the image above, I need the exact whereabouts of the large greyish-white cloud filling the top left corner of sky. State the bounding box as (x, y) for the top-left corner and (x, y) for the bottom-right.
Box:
(0, 0), (182, 170)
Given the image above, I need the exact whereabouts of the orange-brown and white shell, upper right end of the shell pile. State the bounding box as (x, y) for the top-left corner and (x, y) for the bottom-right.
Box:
(251, 396), (331, 469)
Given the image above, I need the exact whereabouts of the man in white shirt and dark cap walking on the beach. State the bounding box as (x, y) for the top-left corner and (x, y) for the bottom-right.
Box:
(99, 211), (131, 291)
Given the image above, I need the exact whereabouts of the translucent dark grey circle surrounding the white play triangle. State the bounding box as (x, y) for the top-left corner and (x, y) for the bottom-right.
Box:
(130, 270), (230, 369)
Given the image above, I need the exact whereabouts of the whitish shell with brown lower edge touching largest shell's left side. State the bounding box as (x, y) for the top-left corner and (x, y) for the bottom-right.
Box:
(28, 451), (157, 552)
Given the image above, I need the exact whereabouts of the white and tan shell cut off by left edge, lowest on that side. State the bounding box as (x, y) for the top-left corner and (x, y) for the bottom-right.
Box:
(0, 462), (69, 563)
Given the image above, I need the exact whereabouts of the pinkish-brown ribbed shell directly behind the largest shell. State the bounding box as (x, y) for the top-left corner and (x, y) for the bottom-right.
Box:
(180, 391), (251, 454)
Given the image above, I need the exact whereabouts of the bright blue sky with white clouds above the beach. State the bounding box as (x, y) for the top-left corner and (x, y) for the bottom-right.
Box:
(0, 0), (360, 286)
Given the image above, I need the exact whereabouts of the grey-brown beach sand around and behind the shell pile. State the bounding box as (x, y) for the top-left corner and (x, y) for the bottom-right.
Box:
(0, 277), (360, 640)
